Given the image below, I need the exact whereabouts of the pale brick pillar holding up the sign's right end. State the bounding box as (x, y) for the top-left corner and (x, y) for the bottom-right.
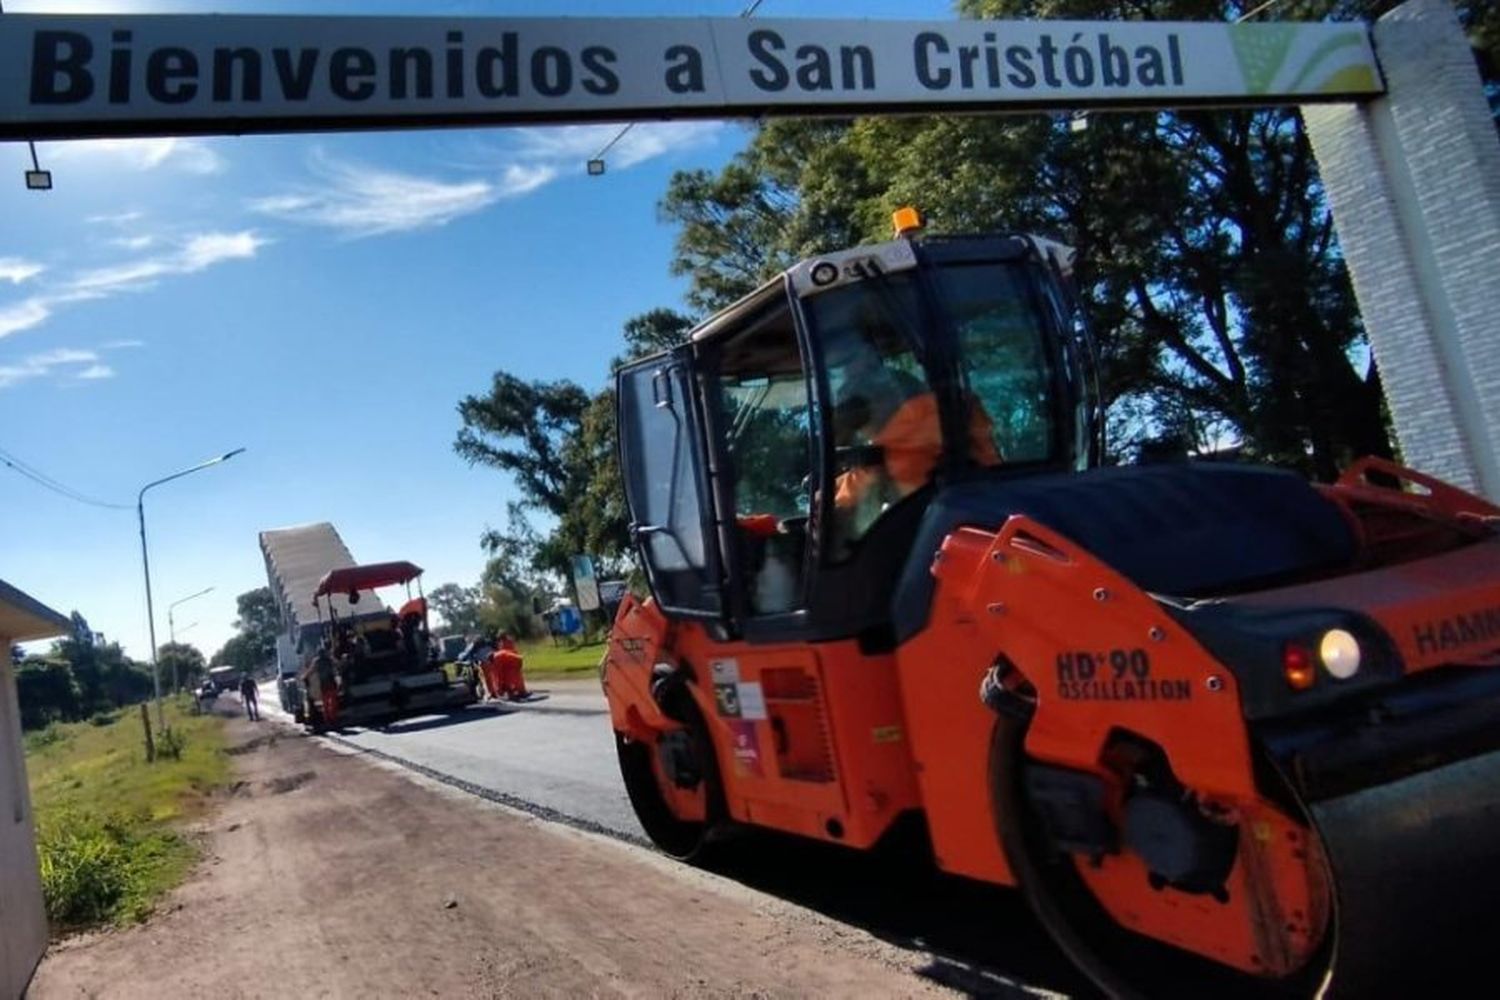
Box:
(1302, 0), (1500, 499)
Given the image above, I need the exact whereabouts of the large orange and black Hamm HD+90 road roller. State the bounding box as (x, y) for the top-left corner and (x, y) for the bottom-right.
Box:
(602, 213), (1500, 996)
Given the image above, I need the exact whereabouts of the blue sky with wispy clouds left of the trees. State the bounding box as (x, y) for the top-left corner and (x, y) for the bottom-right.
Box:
(0, 0), (951, 658)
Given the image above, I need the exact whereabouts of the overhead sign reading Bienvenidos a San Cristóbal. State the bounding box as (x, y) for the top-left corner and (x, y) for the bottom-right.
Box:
(0, 13), (1383, 138)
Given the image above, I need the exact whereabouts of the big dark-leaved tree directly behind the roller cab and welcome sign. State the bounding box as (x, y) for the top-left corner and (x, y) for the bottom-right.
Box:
(662, 0), (1500, 477)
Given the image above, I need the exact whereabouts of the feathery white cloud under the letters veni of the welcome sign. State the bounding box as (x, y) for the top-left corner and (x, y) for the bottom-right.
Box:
(251, 154), (498, 237)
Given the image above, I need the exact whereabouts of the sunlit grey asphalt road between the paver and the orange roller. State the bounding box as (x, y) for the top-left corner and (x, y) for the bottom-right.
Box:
(252, 679), (645, 840)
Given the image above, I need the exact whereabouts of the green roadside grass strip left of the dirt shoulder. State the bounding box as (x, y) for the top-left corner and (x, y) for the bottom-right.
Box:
(26, 702), (230, 933)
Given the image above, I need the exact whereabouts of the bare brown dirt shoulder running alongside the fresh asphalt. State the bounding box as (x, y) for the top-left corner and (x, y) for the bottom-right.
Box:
(30, 710), (951, 1000)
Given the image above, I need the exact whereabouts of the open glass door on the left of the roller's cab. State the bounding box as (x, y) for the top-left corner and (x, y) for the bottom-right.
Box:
(617, 348), (725, 619)
